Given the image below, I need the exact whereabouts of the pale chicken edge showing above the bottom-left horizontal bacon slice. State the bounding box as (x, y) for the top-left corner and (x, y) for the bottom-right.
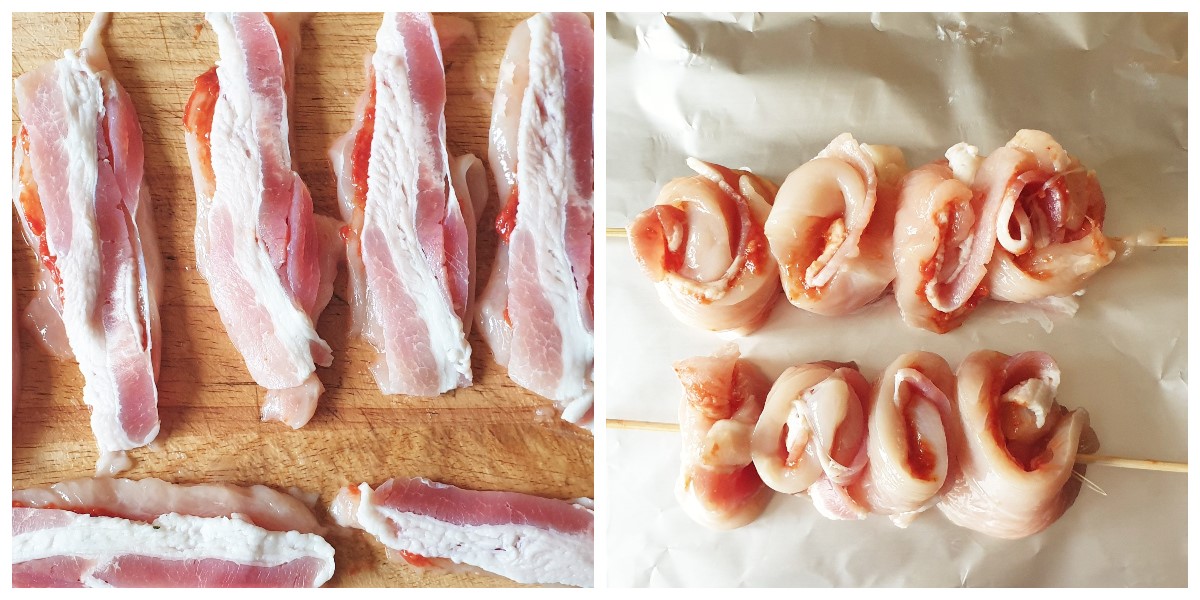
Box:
(12, 478), (322, 533)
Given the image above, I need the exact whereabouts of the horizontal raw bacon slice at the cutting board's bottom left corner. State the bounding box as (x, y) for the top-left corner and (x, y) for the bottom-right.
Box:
(12, 508), (334, 588)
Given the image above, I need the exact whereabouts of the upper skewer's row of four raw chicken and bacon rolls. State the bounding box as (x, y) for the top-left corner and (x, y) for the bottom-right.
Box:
(629, 130), (1115, 334)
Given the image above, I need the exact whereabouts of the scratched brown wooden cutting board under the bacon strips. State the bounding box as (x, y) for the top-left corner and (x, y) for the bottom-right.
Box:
(12, 13), (593, 586)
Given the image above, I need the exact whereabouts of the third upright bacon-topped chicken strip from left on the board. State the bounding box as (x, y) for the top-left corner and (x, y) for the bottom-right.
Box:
(330, 13), (487, 396)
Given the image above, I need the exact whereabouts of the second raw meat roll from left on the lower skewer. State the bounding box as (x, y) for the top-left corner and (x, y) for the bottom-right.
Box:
(751, 361), (871, 518)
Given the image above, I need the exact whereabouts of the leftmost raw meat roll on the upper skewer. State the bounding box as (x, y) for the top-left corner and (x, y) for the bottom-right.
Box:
(629, 158), (779, 334)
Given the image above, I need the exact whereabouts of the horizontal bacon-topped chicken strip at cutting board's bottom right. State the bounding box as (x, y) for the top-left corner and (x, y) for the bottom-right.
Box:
(330, 479), (595, 587)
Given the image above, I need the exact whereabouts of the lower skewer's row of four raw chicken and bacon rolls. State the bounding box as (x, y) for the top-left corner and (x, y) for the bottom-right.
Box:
(676, 344), (1098, 538)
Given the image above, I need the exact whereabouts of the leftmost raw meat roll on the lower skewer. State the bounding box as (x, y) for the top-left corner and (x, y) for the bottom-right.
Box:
(674, 343), (770, 529)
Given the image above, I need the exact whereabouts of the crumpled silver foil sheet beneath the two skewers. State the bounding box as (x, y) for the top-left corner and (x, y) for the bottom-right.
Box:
(601, 14), (1187, 587)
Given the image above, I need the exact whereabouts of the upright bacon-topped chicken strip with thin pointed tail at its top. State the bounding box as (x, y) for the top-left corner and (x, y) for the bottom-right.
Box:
(12, 13), (162, 470)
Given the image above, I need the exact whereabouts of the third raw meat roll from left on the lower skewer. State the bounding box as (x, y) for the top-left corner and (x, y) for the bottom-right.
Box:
(851, 352), (956, 527)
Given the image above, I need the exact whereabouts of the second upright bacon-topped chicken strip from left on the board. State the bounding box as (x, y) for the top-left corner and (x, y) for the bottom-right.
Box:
(184, 13), (342, 427)
